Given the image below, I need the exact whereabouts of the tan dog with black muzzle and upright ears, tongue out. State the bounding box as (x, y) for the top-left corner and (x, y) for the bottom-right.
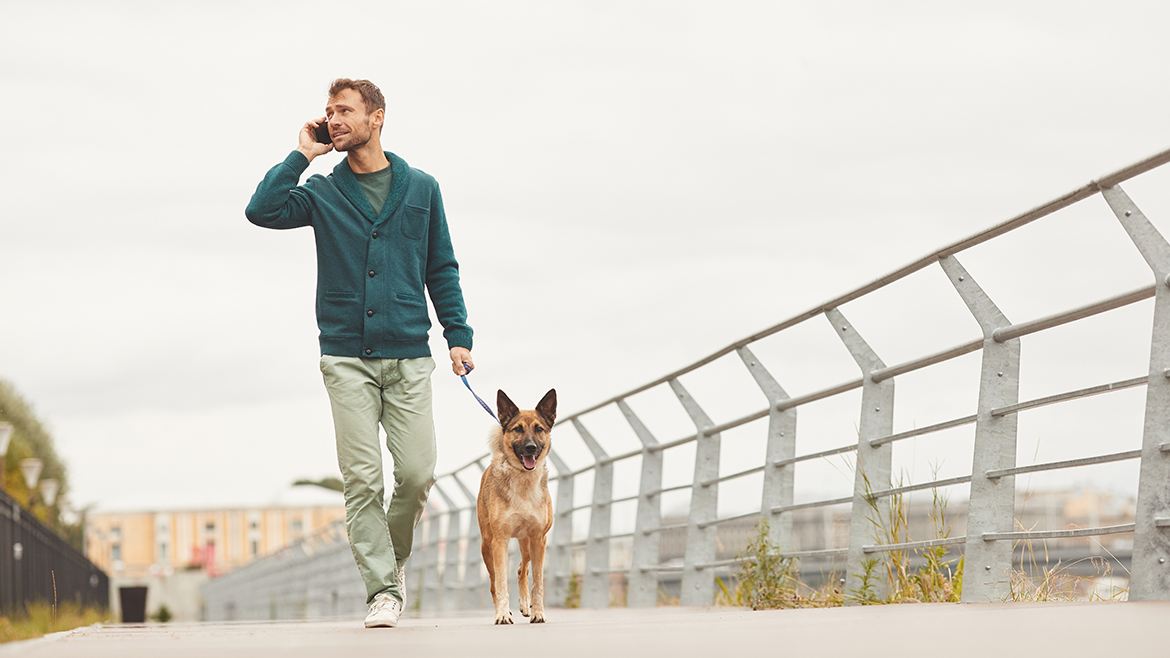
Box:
(475, 389), (557, 624)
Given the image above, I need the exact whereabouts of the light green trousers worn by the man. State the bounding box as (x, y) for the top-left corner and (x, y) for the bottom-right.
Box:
(321, 355), (435, 603)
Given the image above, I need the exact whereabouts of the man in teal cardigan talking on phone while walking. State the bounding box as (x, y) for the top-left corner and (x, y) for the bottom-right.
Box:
(245, 78), (475, 628)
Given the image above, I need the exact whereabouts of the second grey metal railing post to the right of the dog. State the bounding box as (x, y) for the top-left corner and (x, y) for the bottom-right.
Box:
(573, 418), (613, 608)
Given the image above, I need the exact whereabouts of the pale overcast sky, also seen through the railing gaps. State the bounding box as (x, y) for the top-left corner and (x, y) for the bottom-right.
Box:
(0, 1), (1170, 517)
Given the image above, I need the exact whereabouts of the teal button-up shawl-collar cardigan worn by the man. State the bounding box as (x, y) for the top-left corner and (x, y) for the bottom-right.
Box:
(245, 151), (472, 358)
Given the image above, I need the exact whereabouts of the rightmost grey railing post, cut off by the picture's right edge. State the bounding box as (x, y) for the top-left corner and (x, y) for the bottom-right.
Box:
(1101, 181), (1170, 601)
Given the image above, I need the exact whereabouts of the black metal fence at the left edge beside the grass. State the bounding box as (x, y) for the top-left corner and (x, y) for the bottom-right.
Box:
(0, 482), (110, 616)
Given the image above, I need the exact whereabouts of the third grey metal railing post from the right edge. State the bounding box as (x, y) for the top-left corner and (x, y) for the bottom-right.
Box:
(825, 308), (894, 604)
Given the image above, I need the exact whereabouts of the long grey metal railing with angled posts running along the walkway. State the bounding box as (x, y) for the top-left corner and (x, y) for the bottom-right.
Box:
(196, 151), (1170, 618)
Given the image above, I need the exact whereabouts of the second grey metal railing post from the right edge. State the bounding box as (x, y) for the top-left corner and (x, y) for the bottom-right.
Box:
(938, 256), (1020, 603)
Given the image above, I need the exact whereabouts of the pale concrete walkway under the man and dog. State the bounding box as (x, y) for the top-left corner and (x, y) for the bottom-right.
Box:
(0, 602), (1170, 658)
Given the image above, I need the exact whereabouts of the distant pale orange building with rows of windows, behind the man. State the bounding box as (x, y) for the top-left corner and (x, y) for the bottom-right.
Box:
(85, 487), (345, 621)
